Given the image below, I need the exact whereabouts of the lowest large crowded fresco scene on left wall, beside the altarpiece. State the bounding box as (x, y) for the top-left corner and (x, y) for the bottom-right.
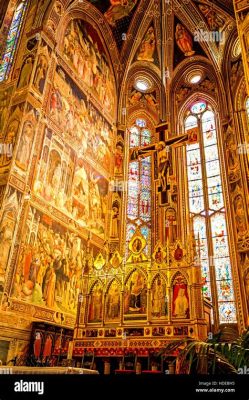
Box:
(12, 207), (99, 313)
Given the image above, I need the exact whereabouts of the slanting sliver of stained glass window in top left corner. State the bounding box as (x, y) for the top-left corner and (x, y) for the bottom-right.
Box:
(0, 0), (28, 82)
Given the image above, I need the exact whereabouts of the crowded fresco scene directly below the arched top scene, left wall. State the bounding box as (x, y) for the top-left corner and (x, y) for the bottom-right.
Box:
(49, 67), (113, 171)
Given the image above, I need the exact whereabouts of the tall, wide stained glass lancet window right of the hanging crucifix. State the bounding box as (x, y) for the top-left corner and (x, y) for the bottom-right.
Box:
(185, 101), (236, 323)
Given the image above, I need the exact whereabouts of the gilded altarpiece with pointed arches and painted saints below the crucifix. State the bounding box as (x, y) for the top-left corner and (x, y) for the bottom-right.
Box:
(74, 230), (207, 356)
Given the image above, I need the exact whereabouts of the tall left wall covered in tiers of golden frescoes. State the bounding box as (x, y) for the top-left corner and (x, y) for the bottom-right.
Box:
(0, 14), (117, 322)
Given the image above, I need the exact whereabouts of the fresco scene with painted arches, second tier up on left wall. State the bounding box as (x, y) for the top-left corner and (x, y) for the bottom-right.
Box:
(34, 126), (108, 237)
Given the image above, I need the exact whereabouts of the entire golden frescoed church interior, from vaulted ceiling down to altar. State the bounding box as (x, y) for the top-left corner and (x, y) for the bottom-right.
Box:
(0, 0), (249, 373)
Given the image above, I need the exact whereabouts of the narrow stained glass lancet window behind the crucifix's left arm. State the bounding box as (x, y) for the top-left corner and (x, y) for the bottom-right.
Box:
(126, 119), (152, 253)
